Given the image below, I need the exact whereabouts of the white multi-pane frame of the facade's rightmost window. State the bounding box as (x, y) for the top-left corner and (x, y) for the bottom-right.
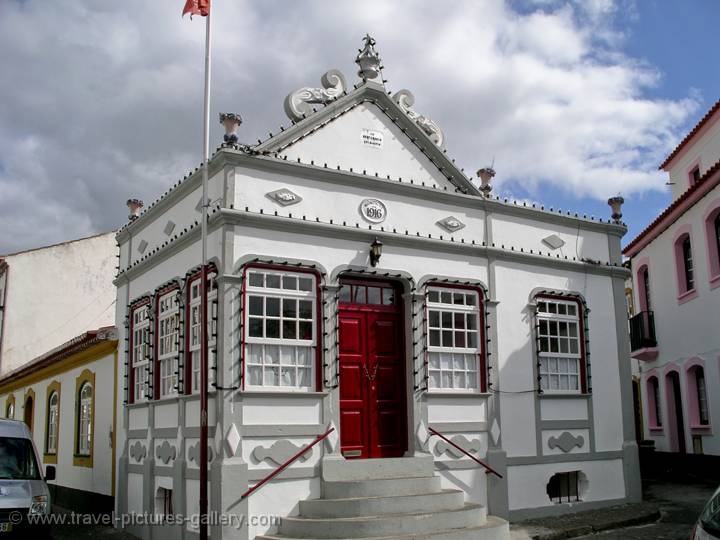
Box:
(535, 296), (585, 395)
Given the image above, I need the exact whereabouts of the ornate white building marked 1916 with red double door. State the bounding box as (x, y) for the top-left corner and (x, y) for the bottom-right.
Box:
(115, 38), (640, 538)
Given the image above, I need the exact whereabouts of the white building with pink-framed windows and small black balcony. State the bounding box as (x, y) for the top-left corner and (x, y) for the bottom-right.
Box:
(624, 102), (720, 455)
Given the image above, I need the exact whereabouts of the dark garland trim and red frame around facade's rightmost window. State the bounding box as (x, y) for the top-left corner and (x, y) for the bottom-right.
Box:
(533, 291), (592, 396)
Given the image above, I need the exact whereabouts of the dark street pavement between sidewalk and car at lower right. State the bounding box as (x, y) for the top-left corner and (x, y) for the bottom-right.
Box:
(580, 481), (717, 540)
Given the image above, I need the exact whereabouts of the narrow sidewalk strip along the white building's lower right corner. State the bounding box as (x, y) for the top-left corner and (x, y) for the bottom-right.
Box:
(510, 502), (660, 540)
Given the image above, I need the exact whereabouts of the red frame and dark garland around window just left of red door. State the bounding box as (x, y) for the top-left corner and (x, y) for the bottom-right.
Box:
(240, 262), (324, 393)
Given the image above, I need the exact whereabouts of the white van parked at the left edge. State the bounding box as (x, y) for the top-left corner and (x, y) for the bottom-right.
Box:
(0, 419), (55, 538)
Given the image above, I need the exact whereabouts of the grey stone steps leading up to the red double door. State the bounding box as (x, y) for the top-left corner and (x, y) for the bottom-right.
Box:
(256, 456), (510, 540)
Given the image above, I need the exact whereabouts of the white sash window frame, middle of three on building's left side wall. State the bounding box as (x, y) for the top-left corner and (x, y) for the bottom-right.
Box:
(156, 289), (180, 398)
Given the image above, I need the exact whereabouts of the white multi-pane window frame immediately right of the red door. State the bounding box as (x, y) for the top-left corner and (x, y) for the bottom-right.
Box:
(425, 285), (484, 394)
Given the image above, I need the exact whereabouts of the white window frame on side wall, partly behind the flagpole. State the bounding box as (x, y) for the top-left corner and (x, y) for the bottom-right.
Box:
(187, 272), (217, 394)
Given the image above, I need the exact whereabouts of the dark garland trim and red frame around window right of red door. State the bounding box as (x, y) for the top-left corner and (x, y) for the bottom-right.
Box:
(423, 280), (489, 395)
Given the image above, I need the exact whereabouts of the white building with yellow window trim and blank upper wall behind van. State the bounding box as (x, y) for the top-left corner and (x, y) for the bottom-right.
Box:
(0, 233), (117, 512)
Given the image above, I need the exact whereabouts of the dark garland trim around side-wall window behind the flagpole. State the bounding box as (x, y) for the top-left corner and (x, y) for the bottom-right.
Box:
(180, 265), (218, 395)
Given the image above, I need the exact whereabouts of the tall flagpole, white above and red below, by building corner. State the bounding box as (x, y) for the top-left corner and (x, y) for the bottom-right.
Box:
(199, 5), (212, 540)
